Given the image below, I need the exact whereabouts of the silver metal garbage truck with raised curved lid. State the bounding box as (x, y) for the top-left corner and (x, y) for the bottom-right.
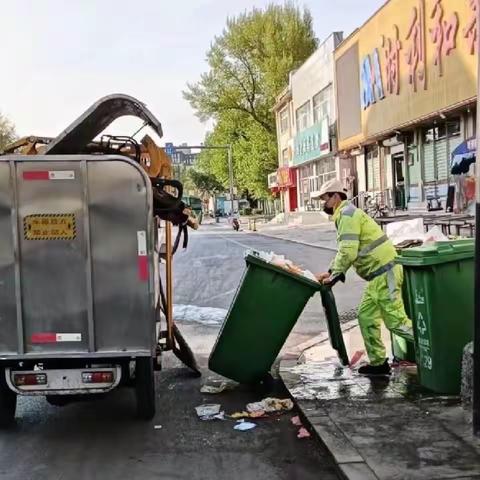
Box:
(0, 95), (197, 425)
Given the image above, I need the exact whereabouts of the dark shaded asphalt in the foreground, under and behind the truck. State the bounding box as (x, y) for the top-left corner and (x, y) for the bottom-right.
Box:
(0, 368), (337, 480)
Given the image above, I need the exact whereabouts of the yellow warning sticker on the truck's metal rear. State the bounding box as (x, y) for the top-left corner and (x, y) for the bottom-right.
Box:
(23, 213), (77, 240)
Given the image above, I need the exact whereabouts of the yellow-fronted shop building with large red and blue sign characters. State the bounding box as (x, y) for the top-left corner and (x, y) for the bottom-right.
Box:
(335, 0), (478, 210)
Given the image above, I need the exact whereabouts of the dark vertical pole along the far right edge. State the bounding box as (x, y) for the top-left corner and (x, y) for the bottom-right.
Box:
(473, 5), (480, 436)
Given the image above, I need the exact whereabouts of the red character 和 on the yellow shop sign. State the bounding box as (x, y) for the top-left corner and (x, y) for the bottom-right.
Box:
(429, 0), (458, 76)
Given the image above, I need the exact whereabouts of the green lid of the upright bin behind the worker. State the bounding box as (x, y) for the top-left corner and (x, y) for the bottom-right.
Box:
(397, 238), (475, 267)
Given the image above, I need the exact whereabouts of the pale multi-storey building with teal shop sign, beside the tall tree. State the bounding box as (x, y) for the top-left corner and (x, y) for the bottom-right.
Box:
(269, 32), (349, 212)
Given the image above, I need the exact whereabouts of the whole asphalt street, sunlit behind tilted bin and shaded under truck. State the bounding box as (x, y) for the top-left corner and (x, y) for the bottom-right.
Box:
(0, 221), (354, 480)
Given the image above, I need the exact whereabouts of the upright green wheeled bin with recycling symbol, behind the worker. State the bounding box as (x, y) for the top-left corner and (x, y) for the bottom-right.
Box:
(398, 239), (475, 395)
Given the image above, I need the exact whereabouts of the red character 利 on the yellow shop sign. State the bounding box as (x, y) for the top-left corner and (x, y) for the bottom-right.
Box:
(405, 0), (427, 92)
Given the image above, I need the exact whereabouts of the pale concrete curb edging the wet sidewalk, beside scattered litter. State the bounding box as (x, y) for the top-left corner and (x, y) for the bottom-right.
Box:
(279, 328), (379, 480)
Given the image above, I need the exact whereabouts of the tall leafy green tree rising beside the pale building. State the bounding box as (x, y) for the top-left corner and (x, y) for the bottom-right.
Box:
(183, 2), (317, 198)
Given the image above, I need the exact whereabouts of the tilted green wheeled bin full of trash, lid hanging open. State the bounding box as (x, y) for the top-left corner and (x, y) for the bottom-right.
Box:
(208, 254), (348, 383)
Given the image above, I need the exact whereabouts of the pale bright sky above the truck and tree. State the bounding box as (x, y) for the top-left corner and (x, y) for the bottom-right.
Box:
(0, 0), (385, 145)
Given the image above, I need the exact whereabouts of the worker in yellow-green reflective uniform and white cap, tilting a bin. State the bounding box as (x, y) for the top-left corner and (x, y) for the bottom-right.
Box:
(317, 180), (413, 375)
